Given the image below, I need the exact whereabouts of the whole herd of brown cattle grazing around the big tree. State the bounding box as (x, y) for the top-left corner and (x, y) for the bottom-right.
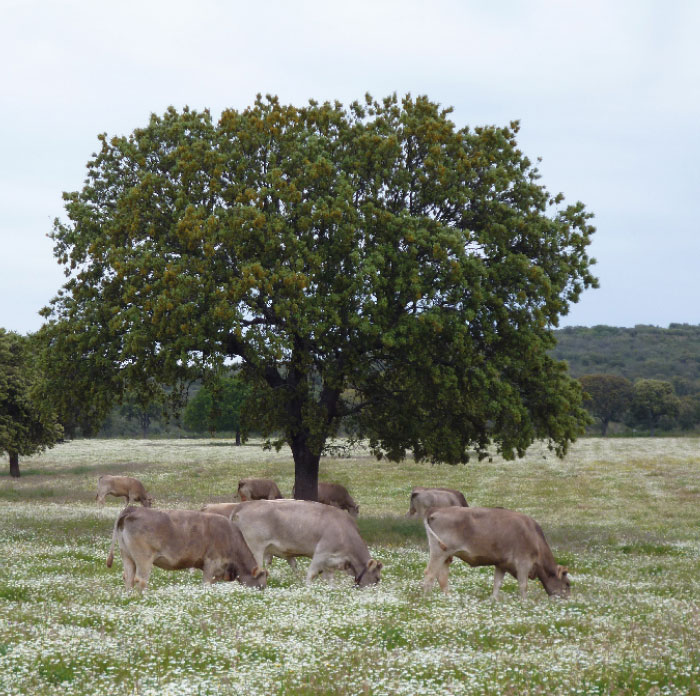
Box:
(97, 475), (570, 599)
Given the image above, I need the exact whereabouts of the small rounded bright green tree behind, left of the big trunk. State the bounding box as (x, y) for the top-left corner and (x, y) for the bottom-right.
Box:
(183, 377), (248, 445)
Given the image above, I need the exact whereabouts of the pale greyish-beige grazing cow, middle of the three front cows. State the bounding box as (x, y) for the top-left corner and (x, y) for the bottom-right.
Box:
(231, 500), (382, 587)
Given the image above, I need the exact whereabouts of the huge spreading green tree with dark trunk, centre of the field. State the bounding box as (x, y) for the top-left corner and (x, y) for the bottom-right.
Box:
(39, 96), (596, 499)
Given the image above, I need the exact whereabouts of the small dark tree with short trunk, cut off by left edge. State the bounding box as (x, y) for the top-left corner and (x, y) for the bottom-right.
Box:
(0, 329), (63, 478)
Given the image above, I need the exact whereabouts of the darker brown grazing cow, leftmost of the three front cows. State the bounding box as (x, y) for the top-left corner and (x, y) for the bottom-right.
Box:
(107, 507), (267, 590)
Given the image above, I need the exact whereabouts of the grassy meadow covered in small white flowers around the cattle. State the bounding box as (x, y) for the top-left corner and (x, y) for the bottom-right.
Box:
(0, 438), (700, 696)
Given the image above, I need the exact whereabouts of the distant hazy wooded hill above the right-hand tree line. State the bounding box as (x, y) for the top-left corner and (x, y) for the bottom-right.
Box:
(552, 324), (700, 396)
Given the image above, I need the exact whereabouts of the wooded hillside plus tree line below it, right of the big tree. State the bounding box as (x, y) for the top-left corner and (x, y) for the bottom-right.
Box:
(552, 324), (700, 435)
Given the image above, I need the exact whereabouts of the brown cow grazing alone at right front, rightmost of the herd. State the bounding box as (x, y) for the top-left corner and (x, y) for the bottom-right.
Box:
(423, 507), (571, 599)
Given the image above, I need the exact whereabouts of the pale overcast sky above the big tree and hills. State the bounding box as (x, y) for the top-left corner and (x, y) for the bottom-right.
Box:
(0, 0), (700, 333)
